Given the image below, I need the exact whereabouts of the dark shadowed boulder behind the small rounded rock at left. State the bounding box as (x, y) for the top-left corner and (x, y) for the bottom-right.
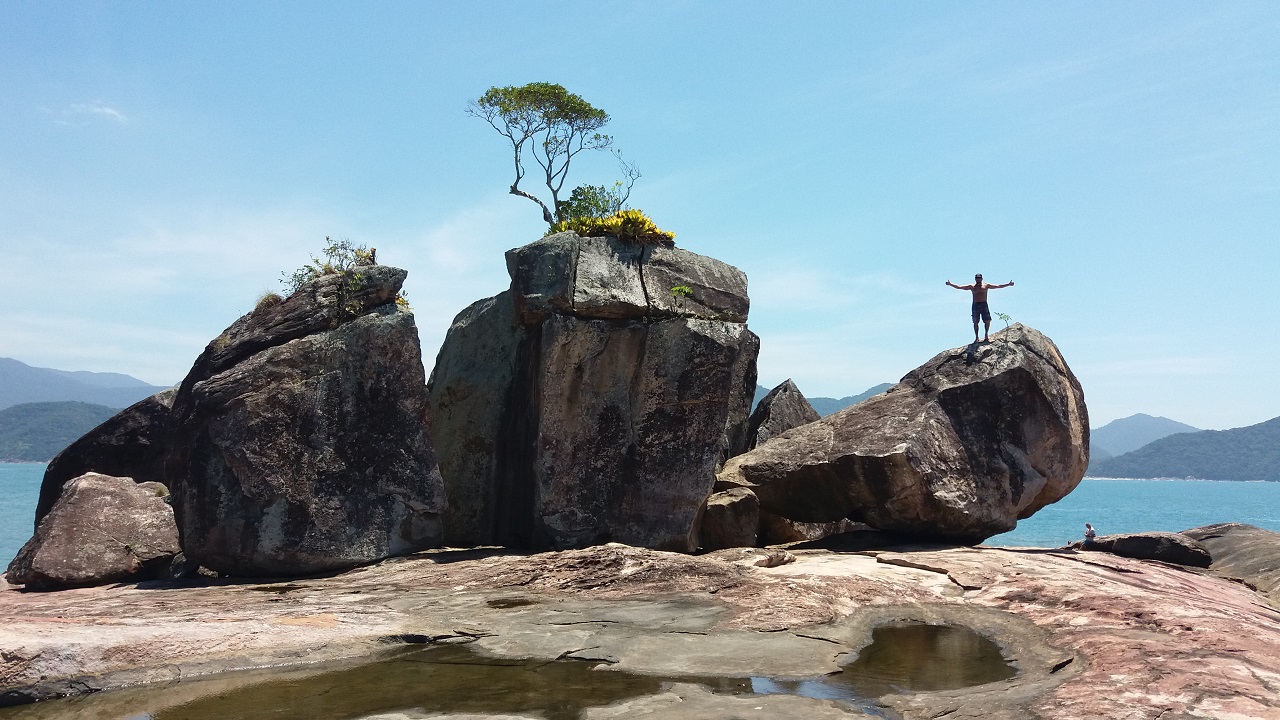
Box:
(36, 388), (178, 527)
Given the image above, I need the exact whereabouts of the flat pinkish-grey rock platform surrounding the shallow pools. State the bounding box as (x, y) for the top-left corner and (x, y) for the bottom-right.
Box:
(0, 544), (1280, 720)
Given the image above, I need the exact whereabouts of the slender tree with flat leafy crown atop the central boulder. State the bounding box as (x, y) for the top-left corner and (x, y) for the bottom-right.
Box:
(467, 82), (640, 225)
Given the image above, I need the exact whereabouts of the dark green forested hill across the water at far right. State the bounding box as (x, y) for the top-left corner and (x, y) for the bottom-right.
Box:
(1089, 418), (1280, 482)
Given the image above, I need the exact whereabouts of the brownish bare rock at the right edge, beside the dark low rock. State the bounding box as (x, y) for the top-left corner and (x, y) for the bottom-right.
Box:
(1181, 523), (1280, 607)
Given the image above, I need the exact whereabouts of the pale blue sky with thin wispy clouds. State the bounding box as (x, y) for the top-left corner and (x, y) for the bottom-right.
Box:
(0, 0), (1280, 428)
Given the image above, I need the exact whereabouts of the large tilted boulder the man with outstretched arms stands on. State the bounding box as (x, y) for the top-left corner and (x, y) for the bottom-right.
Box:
(718, 324), (1089, 543)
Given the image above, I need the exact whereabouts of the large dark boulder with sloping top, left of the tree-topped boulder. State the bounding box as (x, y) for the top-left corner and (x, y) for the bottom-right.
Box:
(166, 265), (445, 577)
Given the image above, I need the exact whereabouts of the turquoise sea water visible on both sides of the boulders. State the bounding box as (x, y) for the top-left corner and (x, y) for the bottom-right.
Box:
(0, 462), (1280, 570)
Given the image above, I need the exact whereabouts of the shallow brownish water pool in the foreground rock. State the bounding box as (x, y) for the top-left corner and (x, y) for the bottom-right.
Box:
(0, 624), (1016, 720)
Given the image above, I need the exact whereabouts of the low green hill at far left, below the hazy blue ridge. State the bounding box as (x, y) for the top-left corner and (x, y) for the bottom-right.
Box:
(0, 401), (119, 462)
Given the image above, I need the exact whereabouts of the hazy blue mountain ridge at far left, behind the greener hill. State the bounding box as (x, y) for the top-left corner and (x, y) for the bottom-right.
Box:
(0, 357), (165, 410)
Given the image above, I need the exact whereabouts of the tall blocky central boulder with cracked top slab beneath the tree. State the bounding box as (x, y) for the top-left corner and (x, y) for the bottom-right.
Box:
(430, 233), (759, 551)
